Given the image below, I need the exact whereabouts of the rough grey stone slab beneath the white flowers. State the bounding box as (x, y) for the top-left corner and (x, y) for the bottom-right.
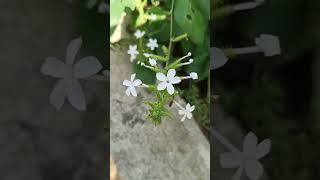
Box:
(110, 51), (210, 180)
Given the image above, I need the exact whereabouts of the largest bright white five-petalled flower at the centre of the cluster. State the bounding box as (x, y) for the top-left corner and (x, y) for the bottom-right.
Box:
(156, 69), (181, 95)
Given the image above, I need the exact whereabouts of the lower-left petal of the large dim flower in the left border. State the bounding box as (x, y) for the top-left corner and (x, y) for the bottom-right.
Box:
(49, 79), (67, 109)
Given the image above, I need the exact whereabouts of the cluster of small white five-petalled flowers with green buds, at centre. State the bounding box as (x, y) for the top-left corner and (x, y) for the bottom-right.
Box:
(122, 30), (198, 124)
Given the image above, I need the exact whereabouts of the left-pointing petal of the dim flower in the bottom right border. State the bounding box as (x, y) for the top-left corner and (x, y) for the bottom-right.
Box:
(220, 152), (243, 168)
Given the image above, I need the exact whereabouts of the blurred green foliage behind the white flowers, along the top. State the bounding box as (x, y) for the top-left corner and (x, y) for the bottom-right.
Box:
(110, 0), (210, 82)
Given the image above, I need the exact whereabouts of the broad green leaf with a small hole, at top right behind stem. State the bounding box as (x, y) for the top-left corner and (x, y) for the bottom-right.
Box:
(174, 0), (207, 44)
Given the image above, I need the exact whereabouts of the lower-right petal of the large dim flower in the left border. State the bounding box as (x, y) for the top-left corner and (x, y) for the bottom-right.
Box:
(66, 79), (86, 111)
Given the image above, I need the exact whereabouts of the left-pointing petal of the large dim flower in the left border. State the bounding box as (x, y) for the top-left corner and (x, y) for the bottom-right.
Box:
(41, 57), (67, 78)
